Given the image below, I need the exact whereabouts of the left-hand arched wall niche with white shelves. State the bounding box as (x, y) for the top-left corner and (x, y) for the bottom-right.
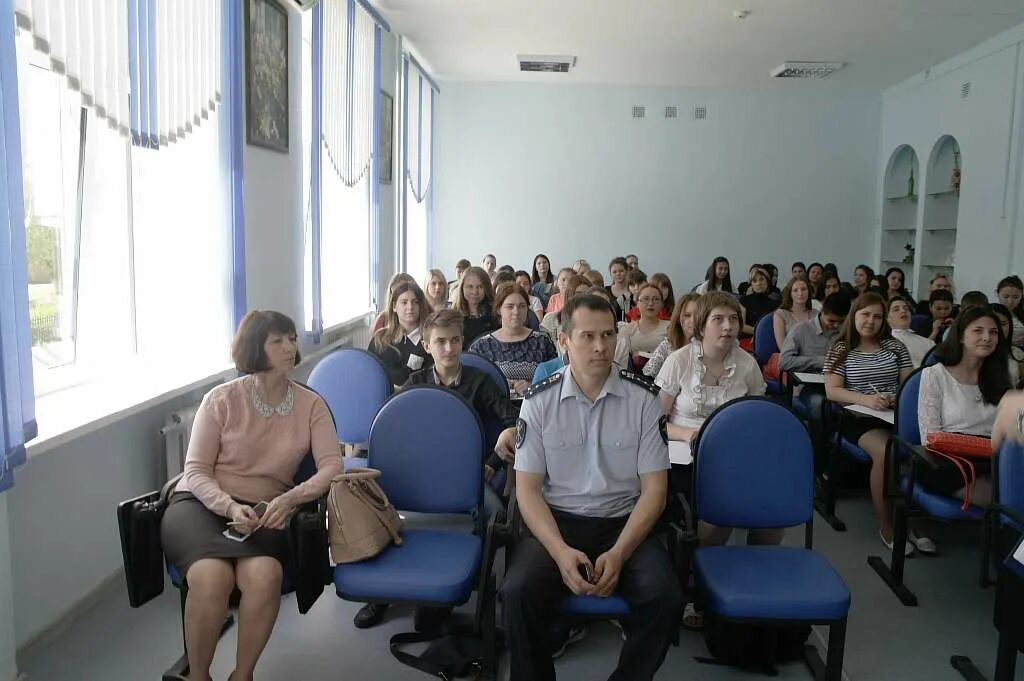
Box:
(879, 144), (921, 284)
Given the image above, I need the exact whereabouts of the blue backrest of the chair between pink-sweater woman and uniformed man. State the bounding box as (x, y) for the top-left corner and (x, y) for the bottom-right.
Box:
(368, 386), (483, 513)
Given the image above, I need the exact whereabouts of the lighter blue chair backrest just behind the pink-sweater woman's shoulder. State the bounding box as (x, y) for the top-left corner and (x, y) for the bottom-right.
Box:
(308, 348), (393, 443)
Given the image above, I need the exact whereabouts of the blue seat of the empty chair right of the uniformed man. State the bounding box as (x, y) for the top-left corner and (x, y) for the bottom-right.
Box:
(694, 546), (850, 622)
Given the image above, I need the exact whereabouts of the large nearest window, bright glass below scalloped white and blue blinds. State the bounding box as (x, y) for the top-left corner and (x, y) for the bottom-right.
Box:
(16, 4), (232, 397)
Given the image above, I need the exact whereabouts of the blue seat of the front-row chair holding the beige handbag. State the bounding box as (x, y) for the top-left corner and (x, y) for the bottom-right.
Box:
(334, 529), (483, 605)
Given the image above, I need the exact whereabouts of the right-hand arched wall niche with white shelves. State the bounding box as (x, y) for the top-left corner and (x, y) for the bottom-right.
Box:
(918, 135), (963, 291)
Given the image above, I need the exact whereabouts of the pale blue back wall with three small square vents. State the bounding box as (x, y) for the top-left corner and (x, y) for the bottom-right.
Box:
(433, 83), (879, 292)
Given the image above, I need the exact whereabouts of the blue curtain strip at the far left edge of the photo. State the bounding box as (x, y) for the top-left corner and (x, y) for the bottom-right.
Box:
(0, 0), (37, 492)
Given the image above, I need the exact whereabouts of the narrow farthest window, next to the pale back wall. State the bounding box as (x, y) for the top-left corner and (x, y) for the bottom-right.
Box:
(402, 58), (437, 282)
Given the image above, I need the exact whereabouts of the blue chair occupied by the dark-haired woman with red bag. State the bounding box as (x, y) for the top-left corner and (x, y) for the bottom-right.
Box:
(867, 367), (984, 606)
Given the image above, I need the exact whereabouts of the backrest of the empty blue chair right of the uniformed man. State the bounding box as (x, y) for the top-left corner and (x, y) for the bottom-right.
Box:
(694, 397), (814, 527)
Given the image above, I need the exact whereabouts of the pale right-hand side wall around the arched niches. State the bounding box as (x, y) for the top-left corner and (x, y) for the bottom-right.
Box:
(877, 25), (1024, 296)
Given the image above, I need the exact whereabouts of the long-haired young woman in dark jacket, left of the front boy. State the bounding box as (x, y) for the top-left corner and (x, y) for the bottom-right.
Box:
(367, 283), (430, 386)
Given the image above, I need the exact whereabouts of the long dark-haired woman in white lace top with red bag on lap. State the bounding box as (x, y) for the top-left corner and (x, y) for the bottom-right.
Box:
(916, 306), (1011, 507)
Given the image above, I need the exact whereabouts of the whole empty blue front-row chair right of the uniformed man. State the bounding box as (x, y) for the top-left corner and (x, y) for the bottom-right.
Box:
(693, 397), (850, 681)
